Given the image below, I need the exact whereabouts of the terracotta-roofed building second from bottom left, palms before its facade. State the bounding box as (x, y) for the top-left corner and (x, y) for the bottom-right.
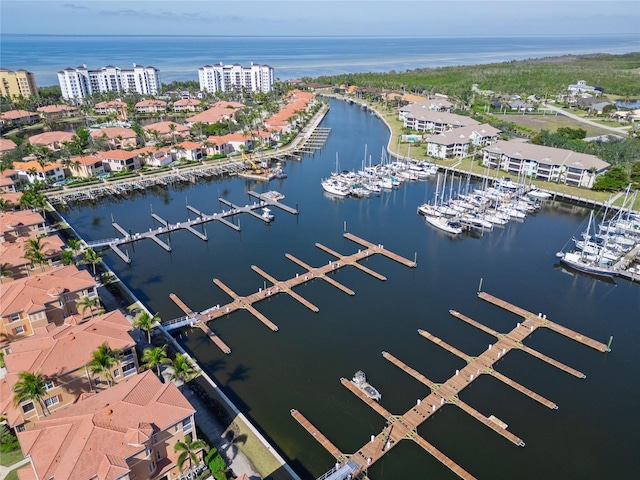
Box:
(0, 307), (139, 431)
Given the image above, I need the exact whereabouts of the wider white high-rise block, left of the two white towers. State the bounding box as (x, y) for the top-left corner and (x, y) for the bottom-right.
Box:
(58, 63), (160, 101)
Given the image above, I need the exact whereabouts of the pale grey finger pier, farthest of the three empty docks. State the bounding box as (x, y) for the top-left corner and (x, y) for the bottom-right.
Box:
(86, 192), (298, 263)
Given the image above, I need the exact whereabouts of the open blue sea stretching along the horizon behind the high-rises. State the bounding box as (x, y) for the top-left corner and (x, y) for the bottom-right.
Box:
(0, 34), (640, 86)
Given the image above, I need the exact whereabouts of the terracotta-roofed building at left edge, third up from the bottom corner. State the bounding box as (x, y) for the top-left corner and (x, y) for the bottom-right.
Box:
(0, 265), (97, 340)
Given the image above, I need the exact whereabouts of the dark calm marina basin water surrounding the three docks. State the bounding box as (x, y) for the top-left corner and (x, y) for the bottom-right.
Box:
(56, 98), (640, 480)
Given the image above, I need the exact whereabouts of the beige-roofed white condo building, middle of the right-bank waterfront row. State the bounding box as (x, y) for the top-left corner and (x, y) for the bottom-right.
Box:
(423, 124), (501, 159)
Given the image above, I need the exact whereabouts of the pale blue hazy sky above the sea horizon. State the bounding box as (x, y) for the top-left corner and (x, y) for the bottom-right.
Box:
(0, 0), (640, 36)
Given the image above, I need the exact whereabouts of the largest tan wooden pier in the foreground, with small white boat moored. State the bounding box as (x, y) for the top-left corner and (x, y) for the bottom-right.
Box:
(291, 290), (609, 480)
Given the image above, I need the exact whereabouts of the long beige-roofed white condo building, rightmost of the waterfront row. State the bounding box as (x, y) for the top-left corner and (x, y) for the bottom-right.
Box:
(482, 140), (609, 188)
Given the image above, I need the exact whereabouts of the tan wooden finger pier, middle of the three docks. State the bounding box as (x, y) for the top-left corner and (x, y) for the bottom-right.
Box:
(162, 232), (416, 353)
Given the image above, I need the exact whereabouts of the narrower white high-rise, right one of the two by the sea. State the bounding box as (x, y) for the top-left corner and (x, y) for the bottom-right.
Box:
(198, 62), (273, 93)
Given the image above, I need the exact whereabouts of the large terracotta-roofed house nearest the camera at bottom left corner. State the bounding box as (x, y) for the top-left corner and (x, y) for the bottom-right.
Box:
(18, 371), (196, 480)
